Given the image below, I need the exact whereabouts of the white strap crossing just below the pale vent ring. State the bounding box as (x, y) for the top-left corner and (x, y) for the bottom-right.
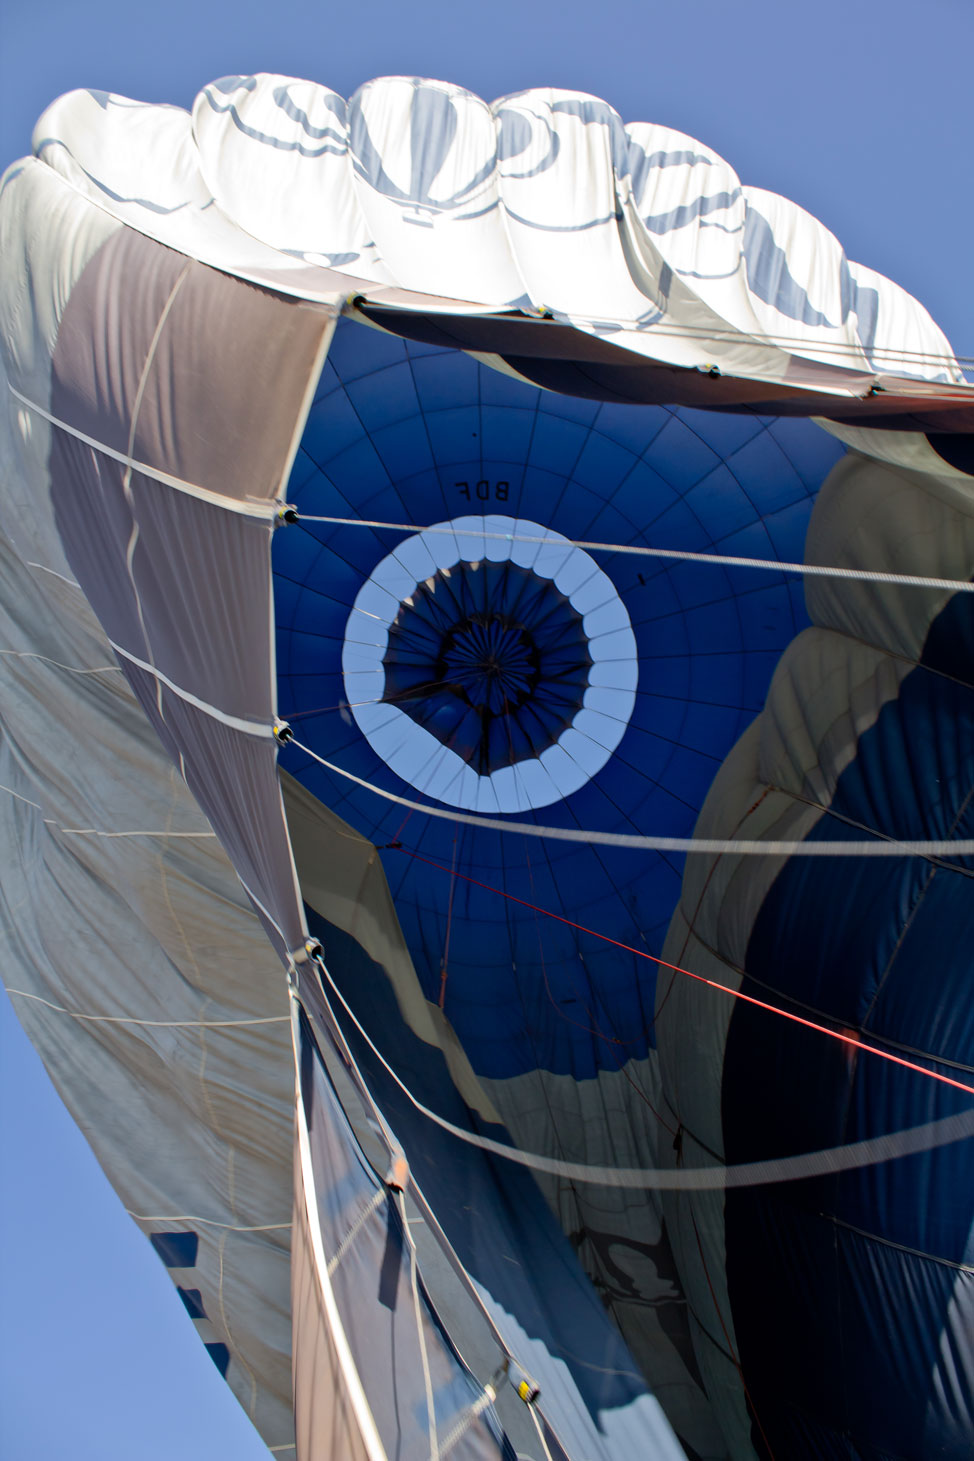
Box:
(288, 738), (974, 875)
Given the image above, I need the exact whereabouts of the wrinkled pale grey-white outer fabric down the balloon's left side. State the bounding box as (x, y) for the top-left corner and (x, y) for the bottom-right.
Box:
(0, 164), (294, 1455)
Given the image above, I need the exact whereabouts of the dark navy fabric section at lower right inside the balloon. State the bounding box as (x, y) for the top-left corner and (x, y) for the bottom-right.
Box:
(723, 595), (974, 1461)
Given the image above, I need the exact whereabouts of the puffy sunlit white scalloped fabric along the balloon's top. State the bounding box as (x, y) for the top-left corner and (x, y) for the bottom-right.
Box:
(26, 76), (962, 394)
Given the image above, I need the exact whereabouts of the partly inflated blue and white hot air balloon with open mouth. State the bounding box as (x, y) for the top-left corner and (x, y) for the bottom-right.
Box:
(0, 76), (974, 1461)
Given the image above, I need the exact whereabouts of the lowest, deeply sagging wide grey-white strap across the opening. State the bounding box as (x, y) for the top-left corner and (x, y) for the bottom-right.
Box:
(317, 960), (974, 1192)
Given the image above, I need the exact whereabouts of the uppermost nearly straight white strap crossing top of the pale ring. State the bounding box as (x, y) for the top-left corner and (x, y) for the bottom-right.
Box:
(298, 511), (974, 593)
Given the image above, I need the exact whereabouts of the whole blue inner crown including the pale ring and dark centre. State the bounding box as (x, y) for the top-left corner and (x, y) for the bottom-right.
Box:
(273, 320), (843, 1080)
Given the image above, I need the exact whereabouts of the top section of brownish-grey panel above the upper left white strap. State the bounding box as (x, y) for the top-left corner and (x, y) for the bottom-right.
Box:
(51, 229), (333, 501)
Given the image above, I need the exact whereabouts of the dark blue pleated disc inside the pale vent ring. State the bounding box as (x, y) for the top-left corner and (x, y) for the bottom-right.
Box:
(383, 561), (591, 776)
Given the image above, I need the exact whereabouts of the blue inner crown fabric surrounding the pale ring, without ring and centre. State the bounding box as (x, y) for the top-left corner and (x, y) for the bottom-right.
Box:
(273, 321), (843, 1098)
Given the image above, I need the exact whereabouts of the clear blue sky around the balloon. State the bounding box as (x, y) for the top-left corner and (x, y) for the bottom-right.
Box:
(0, 0), (974, 1461)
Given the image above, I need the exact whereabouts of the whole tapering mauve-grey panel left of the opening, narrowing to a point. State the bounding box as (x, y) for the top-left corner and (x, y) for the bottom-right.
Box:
(44, 222), (343, 955)
